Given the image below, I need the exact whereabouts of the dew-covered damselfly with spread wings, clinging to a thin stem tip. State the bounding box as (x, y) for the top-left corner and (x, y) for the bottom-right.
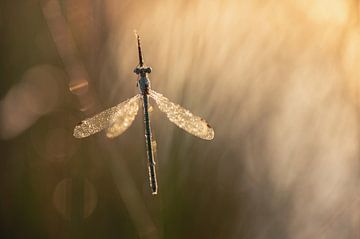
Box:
(74, 32), (214, 194)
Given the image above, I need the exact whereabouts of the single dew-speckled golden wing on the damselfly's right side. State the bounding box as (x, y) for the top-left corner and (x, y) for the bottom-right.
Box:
(150, 90), (214, 140)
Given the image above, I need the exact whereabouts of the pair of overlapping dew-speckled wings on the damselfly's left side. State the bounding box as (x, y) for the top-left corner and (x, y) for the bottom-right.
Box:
(74, 94), (140, 138)
